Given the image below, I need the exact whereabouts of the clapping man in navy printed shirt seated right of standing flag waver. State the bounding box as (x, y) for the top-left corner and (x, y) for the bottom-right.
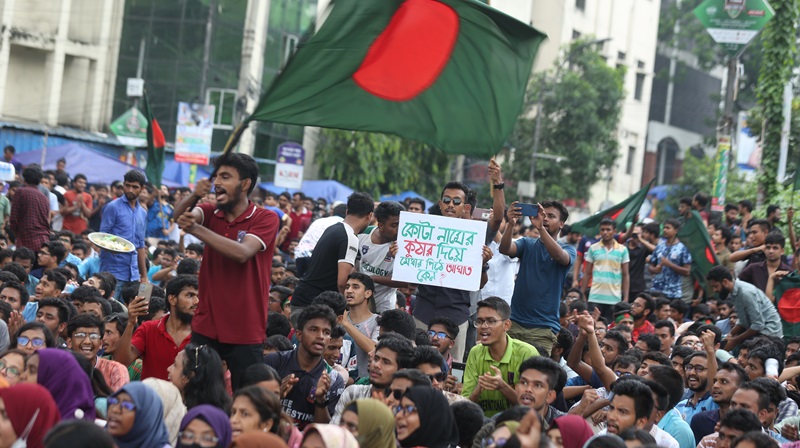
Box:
(263, 304), (344, 430)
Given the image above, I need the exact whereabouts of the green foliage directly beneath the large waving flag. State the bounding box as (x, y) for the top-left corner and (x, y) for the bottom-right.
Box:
(316, 129), (453, 199)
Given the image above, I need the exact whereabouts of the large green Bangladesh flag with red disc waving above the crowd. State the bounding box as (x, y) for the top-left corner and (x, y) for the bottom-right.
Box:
(248, 0), (545, 157)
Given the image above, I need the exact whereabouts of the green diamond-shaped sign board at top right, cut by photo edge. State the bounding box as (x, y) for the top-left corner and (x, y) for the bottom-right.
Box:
(694, 0), (775, 56)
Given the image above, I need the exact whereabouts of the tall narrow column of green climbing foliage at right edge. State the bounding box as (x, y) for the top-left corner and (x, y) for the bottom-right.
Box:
(758, 0), (797, 202)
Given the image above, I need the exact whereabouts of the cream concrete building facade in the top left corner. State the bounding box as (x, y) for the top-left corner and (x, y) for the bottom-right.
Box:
(0, 0), (125, 132)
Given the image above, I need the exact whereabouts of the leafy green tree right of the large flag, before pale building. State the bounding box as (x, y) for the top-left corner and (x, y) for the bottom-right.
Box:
(504, 39), (625, 199)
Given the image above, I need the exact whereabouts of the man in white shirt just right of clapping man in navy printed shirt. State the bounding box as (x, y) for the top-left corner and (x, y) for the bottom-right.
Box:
(331, 333), (412, 425)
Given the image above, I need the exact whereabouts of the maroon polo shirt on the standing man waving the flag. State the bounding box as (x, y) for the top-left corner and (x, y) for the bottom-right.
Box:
(192, 202), (280, 344)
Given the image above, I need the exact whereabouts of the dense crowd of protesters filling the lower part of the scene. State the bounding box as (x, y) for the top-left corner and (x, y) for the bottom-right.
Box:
(0, 148), (800, 448)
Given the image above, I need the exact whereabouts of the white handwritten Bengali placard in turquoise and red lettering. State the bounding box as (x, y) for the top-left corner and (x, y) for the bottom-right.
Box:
(392, 212), (486, 291)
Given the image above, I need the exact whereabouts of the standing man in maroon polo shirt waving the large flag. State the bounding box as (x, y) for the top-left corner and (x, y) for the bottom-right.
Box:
(175, 153), (280, 389)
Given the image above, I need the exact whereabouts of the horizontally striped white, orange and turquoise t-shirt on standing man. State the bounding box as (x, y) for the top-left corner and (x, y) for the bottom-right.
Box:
(586, 240), (631, 305)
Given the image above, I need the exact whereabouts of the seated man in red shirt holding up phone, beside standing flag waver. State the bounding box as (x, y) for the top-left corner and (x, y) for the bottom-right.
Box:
(114, 275), (199, 380)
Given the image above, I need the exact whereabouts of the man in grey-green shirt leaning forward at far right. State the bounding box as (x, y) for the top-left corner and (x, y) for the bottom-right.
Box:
(706, 266), (783, 351)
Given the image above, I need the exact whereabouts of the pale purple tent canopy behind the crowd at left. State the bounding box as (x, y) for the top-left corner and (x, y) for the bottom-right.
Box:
(15, 143), (183, 187)
